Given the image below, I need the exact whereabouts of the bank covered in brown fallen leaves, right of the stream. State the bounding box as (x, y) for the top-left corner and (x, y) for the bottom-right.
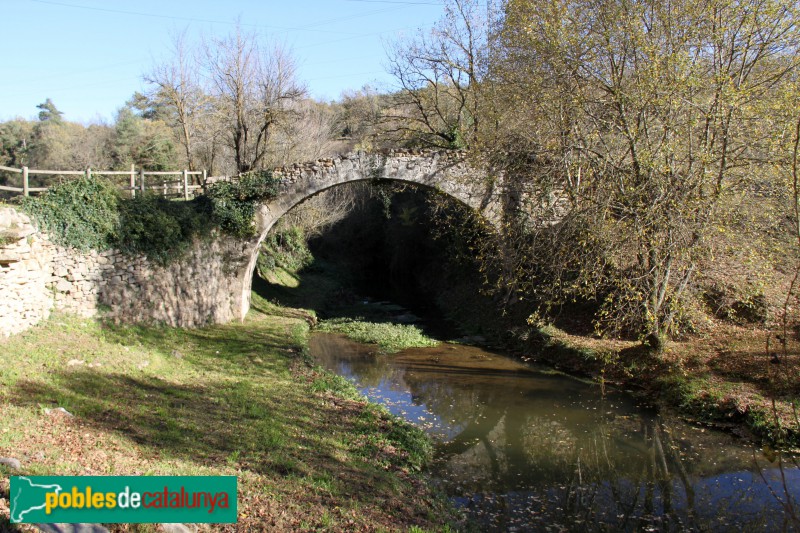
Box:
(524, 323), (800, 448)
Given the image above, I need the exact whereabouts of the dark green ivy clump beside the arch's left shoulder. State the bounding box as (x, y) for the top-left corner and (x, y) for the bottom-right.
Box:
(207, 170), (279, 238)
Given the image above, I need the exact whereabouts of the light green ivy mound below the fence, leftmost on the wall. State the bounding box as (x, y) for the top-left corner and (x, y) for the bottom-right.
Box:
(22, 177), (120, 251)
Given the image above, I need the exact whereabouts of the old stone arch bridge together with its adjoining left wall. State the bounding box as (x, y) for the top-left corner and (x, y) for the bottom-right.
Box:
(0, 151), (501, 335)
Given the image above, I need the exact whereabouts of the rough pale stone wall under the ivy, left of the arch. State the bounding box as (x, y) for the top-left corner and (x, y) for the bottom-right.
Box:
(0, 208), (255, 336)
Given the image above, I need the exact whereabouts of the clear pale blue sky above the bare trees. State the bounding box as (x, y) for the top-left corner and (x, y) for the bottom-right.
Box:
(0, 0), (443, 123)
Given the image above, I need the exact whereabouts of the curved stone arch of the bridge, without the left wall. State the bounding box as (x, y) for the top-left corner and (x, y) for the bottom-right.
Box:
(238, 151), (499, 320)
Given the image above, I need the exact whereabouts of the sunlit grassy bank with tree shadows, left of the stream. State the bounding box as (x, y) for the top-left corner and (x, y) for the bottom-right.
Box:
(0, 295), (456, 531)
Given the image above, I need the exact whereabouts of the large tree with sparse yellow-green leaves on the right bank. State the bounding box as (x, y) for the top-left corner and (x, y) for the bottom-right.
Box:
(490, 0), (799, 345)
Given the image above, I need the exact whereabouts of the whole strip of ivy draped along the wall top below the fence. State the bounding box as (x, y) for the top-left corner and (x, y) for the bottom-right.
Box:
(22, 171), (278, 265)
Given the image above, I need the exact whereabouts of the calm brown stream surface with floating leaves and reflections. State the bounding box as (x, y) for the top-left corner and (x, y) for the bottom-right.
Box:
(311, 334), (800, 531)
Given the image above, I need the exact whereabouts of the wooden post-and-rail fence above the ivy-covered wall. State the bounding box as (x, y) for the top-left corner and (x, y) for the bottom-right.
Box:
(0, 165), (226, 200)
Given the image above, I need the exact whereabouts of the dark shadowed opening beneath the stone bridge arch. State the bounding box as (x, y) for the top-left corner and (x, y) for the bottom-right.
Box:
(247, 180), (500, 332)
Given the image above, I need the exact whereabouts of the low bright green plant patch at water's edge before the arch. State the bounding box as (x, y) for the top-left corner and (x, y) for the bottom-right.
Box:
(318, 317), (439, 353)
